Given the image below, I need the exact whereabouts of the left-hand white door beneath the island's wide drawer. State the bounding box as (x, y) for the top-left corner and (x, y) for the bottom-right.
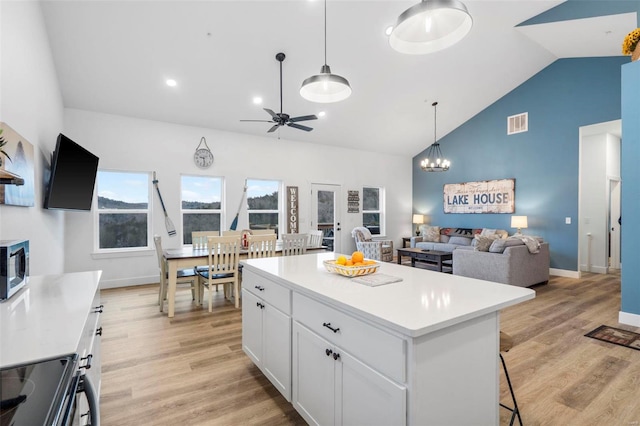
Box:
(292, 321), (336, 425)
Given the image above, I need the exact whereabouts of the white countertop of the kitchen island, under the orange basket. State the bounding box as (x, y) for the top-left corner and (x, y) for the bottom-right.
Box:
(241, 253), (535, 337)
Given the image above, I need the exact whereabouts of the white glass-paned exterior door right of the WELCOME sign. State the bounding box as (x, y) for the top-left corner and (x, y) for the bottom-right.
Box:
(310, 183), (342, 253)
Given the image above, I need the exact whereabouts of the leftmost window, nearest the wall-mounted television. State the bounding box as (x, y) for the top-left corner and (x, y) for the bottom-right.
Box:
(96, 170), (151, 250)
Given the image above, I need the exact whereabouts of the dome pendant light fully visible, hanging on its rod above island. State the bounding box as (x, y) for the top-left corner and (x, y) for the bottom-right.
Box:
(300, 0), (351, 103)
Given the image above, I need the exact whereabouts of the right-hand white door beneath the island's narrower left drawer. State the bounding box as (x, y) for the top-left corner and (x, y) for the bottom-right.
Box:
(262, 303), (291, 401)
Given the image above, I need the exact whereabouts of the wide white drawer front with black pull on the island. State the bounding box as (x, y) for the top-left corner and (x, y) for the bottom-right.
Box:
(293, 293), (406, 383)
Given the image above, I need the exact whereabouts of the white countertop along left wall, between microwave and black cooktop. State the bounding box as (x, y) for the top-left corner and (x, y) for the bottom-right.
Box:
(0, 271), (102, 368)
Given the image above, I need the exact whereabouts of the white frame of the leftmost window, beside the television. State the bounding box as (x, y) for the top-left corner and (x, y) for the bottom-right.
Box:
(92, 168), (153, 254)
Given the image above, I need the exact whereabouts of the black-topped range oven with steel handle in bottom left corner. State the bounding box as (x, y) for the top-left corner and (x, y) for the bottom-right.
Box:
(0, 355), (100, 426)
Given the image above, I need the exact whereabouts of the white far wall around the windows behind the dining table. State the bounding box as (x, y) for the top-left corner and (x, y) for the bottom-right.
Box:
(64, 109), (412, 288)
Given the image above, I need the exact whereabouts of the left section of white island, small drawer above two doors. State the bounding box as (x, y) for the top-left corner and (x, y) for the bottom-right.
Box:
(242, 270), (291, 401)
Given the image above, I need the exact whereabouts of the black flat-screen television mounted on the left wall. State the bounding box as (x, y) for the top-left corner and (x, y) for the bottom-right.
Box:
(44, 133), (98, 210)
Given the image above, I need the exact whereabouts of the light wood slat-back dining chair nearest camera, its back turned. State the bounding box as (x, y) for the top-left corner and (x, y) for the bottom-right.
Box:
(196, 235), (241, 312)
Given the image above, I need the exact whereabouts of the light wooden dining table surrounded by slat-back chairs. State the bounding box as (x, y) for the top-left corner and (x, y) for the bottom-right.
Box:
(160, 241), (328, 318)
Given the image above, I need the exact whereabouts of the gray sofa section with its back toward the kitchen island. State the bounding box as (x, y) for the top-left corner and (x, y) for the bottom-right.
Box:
(453, 243), (549, 287)
